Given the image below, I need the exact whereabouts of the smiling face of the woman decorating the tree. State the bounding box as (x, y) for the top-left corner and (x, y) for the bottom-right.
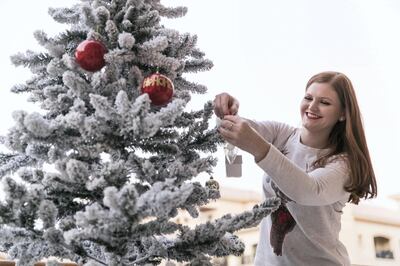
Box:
(300, 83), (344, 135)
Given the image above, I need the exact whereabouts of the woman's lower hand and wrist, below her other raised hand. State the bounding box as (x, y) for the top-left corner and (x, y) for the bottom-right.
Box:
(218, 115), (270, 162)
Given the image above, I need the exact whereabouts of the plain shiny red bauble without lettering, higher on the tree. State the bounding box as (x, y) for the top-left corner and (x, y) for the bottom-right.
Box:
(75, 40), (107, 72)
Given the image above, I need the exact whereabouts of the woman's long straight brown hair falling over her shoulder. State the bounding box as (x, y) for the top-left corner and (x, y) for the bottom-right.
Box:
(306, 71), (377, 204)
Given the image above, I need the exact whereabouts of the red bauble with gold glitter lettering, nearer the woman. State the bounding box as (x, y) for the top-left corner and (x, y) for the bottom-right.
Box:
(141, 73), (174, 106)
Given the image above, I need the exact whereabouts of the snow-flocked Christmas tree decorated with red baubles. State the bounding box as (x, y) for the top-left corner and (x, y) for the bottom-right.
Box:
(0, 0), (279, 265)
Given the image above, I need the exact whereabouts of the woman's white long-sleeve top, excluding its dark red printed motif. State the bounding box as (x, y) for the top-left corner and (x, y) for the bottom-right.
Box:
(249, 120), (350, 266)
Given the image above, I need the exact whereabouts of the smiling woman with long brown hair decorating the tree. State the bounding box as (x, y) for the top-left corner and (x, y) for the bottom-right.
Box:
(214, 72), (377, 266)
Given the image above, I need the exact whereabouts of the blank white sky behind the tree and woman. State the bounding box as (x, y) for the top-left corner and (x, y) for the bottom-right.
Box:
(0, 0), (400, 207)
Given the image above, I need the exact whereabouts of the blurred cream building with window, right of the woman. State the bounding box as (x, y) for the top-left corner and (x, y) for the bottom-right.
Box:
(340, 195), (400, 266)
